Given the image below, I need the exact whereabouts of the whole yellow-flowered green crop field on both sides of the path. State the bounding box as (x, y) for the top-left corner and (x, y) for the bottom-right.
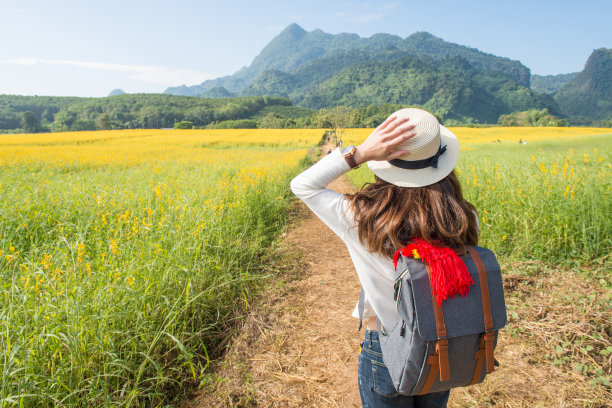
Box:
(0, 128), (612, 406)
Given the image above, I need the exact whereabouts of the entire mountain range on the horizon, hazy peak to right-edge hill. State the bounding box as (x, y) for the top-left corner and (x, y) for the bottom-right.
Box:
(165, 24), (612, 123)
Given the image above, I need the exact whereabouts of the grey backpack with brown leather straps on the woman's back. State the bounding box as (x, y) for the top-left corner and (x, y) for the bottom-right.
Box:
(359, 246), (506, 395)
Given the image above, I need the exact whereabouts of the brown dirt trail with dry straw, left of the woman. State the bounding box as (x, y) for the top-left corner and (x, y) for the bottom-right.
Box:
(190, 147), (363, 408)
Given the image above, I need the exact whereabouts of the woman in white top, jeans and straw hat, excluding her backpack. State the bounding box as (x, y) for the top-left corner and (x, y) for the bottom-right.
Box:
(291, 109), (478, 407)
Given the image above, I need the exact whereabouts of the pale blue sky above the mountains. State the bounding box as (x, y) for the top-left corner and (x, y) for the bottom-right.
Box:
(0, 0), (612, 96)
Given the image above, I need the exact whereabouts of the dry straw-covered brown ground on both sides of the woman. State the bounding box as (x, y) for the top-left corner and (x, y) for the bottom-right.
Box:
(187, 147), (610, 408)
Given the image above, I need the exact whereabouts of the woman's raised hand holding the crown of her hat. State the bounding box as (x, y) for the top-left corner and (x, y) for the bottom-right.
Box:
(354, 116), (416, 164)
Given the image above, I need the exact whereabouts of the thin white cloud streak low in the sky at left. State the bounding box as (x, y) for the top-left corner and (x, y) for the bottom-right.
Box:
(3, 58), (215, 86)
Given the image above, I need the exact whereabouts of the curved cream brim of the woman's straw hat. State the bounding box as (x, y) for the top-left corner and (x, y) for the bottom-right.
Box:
(368, 125), (459, 187)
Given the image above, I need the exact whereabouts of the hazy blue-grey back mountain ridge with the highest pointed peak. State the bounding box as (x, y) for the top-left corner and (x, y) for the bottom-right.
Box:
(165, 23), (530, 96)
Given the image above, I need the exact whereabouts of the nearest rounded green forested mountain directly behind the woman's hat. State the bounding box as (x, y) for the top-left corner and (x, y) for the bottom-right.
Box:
(300, 53), (559, 123)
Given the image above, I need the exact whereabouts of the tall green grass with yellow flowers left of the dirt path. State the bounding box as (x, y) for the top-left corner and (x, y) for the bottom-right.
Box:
(0, 129), (322, 407)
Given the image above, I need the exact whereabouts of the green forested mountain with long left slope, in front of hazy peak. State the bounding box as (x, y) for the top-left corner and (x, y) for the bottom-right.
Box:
(243, 48), (559, 123)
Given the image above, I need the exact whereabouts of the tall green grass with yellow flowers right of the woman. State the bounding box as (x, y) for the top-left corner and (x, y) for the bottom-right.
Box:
(349, 133), (612, 264)
